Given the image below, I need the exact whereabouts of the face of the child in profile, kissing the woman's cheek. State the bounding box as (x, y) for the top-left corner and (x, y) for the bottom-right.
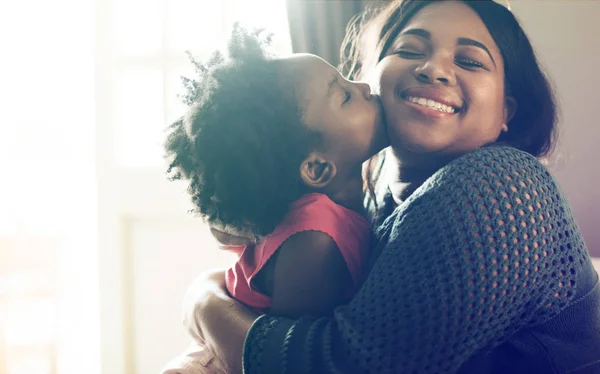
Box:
(278, 54), (389, 170)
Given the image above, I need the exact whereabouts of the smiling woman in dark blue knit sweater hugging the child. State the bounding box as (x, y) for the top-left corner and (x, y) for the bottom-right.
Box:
(182, 0), (600, 374)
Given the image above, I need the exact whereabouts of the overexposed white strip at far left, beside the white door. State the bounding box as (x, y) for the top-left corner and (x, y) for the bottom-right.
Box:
(0, 0), (100, 374)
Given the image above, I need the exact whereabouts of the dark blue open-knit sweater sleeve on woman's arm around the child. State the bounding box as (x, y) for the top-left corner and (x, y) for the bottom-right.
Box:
(244, 146), (586, 374)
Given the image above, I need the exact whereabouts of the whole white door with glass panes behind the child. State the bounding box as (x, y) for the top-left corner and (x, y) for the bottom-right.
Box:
(94, 0), (291, 374)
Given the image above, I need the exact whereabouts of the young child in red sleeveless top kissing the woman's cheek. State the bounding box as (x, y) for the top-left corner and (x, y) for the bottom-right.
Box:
(163, 26), (388, 373)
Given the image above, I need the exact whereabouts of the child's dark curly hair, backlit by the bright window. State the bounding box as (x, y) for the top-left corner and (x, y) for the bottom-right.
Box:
(165, 25), (319, 236)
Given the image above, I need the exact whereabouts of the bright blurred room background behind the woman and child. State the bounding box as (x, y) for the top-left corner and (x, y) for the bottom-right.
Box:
(0, 0), (600, 374)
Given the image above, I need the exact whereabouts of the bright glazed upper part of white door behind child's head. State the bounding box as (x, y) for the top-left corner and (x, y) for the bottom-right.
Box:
(109, 0), (291, 167)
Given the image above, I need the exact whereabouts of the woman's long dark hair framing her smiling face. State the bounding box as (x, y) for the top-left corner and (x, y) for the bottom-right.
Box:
(340, 0), (558, 158)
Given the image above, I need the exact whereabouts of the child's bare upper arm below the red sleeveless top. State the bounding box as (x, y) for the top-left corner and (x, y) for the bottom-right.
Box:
(263, 231), (352, 317)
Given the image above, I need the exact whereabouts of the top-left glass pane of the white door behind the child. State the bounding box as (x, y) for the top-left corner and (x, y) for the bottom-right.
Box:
(112, 0), (162, 56)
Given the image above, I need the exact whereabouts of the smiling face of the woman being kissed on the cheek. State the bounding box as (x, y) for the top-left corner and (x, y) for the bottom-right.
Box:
(370, 2), (515, 164)
